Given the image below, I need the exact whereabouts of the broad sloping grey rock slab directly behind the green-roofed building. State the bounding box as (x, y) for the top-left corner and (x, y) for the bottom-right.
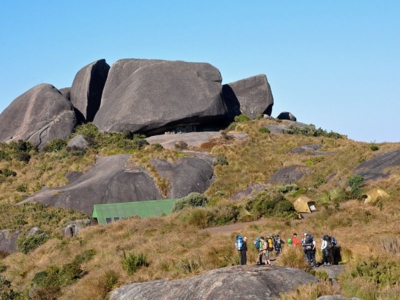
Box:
(19, 154), (213, 214)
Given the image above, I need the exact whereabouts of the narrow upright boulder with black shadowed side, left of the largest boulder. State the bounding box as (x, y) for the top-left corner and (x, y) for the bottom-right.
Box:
(70, 59), (110, 122)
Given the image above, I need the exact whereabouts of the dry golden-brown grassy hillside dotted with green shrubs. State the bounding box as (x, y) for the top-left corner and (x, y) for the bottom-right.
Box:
(0, 119), (400, 299)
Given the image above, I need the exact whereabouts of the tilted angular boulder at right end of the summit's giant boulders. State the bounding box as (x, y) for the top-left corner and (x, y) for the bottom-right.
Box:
(222, 74), (274, 120)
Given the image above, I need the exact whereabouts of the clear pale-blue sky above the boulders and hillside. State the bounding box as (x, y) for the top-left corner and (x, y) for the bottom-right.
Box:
(0, 0), (400, 143)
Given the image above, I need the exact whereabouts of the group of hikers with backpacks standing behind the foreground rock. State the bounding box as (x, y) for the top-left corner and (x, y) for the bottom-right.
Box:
(235, 232), (338, 267)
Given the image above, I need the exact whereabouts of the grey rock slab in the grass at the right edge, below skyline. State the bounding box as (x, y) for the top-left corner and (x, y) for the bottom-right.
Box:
(354, 149), (400, 181)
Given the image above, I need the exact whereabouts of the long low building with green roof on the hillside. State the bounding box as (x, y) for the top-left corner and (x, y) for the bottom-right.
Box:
(92, 198), (179, 225)
